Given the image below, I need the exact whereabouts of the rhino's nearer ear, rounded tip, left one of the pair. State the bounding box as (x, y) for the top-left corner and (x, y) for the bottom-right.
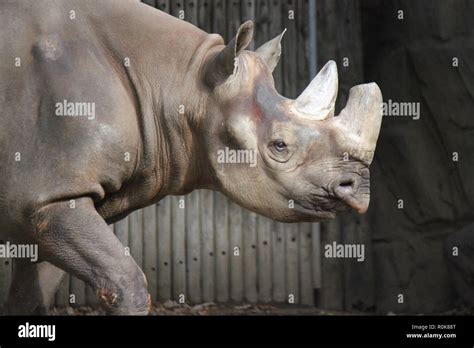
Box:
(206, 21), (253, 85)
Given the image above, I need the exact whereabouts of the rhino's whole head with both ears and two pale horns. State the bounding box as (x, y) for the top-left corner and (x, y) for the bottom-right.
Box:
(203, 21), (382, 222)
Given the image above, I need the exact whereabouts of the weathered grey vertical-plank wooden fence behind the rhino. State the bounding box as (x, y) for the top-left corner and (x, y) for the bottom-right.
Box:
(0, 0), (321, 306)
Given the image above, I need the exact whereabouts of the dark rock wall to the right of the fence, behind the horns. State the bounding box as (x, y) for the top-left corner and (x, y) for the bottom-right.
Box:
(318, 0), (474, 313)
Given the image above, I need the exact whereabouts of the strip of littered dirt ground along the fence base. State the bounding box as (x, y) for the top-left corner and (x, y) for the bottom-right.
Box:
(50, 301), (474, 315)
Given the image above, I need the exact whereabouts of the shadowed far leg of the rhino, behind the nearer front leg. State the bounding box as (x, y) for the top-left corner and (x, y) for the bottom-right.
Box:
(5, 259), (65, 315)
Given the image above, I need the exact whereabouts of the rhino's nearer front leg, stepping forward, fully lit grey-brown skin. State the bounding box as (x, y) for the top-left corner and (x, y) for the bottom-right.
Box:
(32, 198), (150, 315)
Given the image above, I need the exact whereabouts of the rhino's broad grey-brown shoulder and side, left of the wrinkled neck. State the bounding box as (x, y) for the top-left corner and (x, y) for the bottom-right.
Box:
(0, 1), (140, 231)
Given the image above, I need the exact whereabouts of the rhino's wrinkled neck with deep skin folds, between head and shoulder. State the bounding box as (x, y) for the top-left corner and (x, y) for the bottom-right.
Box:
(93, 3), (222, 200)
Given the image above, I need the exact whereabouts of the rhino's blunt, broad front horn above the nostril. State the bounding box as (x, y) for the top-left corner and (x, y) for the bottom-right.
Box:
(334, 83), (382, 164)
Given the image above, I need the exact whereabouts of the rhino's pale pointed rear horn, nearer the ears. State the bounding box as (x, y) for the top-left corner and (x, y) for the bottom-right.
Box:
(293, 60), (338, 120)
